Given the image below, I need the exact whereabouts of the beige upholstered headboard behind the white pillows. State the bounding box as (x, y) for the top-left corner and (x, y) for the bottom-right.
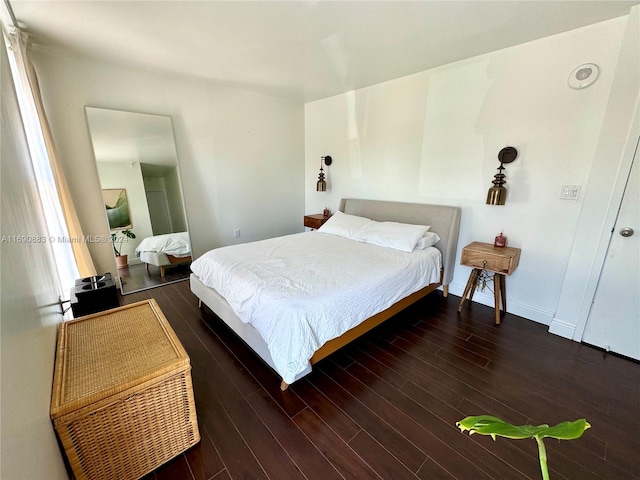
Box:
(339, 198), (460, 285)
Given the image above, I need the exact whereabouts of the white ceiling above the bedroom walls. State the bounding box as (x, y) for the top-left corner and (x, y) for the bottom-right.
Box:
(9, 0), (640, 102)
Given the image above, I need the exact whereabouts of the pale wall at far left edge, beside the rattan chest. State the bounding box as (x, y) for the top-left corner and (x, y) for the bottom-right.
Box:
(0, 34), (68, 480)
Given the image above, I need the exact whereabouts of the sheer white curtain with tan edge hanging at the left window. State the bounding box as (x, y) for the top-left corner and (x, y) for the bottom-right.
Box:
(4, 29), (96, 287)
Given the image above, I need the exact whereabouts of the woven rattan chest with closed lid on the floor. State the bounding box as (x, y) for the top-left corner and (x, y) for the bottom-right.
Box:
(51, 300), (200, 480)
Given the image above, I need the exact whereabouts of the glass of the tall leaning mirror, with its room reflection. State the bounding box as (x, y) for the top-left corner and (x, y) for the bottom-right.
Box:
(85, 107), (191, 294)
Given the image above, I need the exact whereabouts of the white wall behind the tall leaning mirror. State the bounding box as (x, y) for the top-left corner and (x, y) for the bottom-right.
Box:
(33, 47), (304, 280)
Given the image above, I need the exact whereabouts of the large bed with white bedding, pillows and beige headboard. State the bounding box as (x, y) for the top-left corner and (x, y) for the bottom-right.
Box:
(190, 199), (460, 390)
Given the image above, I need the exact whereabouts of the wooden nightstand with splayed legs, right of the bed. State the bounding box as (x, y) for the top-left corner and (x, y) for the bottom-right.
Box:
(458, 242), (520, 325)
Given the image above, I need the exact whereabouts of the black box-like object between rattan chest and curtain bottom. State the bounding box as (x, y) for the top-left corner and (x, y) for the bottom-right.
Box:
(70, 273), (120, 318)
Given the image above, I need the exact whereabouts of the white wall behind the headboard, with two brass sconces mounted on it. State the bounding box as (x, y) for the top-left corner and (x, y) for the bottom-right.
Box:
(305, 17), (628, 324)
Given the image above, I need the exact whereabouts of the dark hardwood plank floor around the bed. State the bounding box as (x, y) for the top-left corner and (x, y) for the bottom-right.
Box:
(123, 281), (640, 480)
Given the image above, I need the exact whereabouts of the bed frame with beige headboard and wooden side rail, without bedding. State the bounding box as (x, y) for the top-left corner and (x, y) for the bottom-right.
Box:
(190, 199), (460, 390)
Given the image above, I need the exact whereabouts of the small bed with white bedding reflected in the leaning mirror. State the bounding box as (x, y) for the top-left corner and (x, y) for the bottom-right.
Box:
(136, 232), (191, 277)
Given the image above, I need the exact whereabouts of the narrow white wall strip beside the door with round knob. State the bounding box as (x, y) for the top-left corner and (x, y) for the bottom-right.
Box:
(549, 5), (640, 341)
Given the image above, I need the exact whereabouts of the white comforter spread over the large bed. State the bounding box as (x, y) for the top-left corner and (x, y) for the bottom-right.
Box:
(191, 231), (441, 383)
